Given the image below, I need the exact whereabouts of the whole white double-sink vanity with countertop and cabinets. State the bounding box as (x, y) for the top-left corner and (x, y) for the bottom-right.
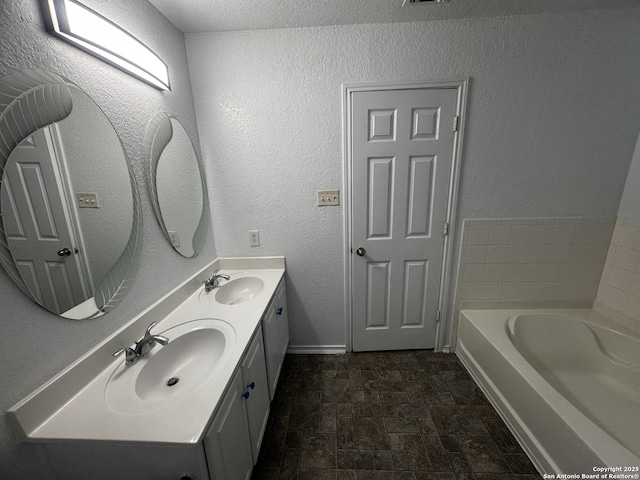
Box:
(8, 257), (289, 480)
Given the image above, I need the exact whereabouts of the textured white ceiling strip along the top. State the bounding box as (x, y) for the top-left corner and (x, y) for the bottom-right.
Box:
(149, 0), (640, 33)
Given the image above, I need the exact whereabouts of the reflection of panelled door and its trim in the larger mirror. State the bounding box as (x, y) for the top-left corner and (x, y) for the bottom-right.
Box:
(1, 125), (92, 314)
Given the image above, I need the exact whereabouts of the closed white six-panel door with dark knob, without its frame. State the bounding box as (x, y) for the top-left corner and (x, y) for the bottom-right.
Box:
(350, 88), (458, 351)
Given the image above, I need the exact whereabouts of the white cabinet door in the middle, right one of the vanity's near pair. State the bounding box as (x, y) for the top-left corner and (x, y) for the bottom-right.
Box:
(242, 327), (269, 464)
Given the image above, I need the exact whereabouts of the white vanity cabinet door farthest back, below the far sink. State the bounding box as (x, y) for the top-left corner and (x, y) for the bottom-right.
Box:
(262, 278), (289, 400)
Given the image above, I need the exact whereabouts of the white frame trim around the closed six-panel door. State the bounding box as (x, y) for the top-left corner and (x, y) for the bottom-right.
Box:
(342, 78), (469, 352)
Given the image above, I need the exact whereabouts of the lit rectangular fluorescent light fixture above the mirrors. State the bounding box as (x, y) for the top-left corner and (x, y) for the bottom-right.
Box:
(45, 0), (171, 90)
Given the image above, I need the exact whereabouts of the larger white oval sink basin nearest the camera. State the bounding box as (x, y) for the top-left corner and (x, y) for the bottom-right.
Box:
(104, 318), (236, 415)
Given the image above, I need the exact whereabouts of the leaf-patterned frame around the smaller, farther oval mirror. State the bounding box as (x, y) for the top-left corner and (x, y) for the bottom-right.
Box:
(145, 112), (209, 258)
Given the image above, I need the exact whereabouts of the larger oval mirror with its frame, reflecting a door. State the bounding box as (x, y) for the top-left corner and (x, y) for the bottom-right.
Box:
(0, 69), (142, 320)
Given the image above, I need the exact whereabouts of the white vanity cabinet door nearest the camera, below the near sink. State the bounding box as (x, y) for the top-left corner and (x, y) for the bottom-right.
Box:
(205, 369), (253, 480)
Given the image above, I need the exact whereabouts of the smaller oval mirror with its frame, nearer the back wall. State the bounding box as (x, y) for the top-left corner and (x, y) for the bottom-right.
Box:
(146, 112), (208, 258)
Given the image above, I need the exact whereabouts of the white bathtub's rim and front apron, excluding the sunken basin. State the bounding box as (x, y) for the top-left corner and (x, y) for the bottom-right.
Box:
(455, 308), (640, 474)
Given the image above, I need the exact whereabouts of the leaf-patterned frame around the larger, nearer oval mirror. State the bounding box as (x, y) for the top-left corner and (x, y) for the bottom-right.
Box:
(0, 69), (142, 320)
